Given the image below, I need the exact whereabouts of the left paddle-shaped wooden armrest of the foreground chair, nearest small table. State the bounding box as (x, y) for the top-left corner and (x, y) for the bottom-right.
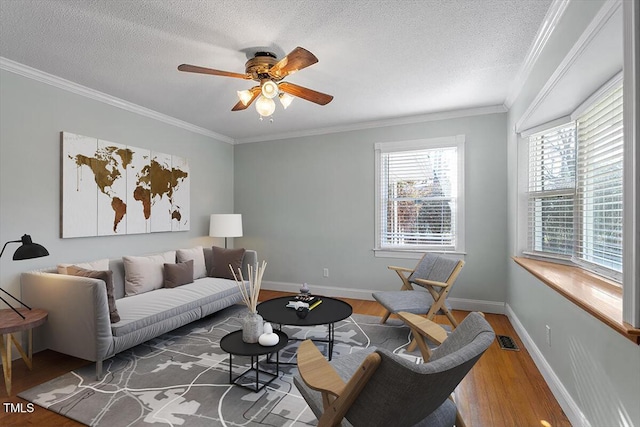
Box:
(298, 340), (345, 397)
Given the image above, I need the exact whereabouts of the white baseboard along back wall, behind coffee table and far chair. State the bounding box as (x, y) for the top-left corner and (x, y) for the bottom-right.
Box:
(262, 281), (505, 314)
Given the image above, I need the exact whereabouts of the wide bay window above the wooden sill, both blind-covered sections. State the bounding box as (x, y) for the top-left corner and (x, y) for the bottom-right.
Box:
(527, 82), (623, 282)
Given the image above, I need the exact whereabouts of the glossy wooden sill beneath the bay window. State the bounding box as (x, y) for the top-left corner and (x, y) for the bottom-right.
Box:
(513, 257), (640, 344)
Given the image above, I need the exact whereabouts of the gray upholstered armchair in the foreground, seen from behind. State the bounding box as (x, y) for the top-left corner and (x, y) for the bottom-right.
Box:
(294, 313), (495, 427)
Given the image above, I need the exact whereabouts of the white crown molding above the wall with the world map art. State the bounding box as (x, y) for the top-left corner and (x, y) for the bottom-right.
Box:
(0, 56), (235, 144)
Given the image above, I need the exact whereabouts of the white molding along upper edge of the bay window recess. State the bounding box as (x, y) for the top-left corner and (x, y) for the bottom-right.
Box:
(516, 0), (622, 132)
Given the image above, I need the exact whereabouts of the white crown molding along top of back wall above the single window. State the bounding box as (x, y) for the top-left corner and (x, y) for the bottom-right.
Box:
(235, 105), (507, 144)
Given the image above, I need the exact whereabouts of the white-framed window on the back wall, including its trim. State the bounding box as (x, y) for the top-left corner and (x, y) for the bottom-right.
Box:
(375, 135), (464, 252)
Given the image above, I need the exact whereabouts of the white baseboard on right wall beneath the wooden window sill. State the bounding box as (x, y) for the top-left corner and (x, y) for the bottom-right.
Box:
(506, 304), (591, 427)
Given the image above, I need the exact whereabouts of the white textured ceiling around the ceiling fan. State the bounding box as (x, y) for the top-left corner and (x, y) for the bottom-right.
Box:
(0, 0), (551, 142)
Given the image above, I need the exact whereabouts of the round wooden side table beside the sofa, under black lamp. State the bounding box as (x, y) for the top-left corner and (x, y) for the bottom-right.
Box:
(0, 308), (48, 396)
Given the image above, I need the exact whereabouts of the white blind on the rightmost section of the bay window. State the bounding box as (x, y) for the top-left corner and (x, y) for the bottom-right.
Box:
(575, 85), (623, 279)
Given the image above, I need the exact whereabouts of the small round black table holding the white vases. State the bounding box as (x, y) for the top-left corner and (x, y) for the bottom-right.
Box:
(220, 330), (289, 392)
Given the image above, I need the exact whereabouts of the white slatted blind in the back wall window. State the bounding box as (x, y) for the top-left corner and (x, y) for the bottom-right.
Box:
(379, 147), (458, 250)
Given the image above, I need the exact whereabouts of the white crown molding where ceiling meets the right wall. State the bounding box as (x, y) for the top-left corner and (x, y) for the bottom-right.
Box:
(504, 0), (570, 108)
